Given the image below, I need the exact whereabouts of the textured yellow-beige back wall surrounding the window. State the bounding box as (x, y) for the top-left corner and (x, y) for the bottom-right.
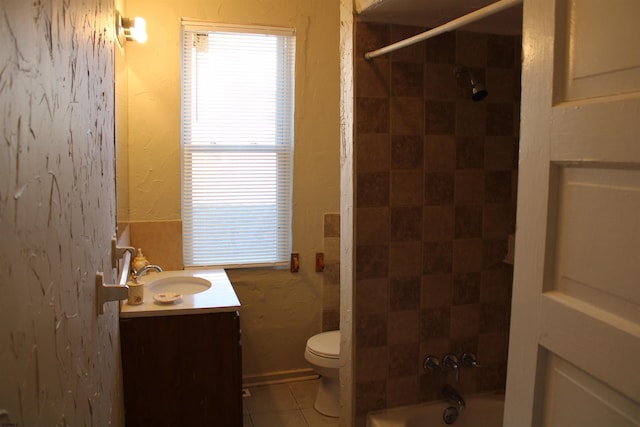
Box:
(120, 0), (340, 379)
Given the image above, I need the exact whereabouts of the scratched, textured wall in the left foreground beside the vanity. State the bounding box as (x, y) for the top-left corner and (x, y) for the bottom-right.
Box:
(0, 0), (123, 426)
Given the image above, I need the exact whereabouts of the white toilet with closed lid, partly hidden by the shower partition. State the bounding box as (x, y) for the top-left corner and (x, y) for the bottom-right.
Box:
(304, 331), (340, 417)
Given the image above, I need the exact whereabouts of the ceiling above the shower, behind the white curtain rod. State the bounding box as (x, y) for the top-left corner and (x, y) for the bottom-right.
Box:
(358, 0), (522, 34)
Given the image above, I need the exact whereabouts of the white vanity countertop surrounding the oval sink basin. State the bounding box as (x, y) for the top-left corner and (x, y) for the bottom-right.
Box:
(120, 270), (240, 318)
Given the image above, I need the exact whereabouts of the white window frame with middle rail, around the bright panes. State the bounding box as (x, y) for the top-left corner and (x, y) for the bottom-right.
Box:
(180, 19), (296, 268)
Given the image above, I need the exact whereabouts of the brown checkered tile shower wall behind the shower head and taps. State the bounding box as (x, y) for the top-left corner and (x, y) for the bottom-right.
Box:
(354, 23), (521, 426)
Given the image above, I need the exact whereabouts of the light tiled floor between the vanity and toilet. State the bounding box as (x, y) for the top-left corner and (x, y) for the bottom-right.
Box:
(243, 380), (338, 427)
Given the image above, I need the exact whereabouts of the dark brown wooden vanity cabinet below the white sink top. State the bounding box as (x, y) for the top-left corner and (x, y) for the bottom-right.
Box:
(120, 312), (242, 427)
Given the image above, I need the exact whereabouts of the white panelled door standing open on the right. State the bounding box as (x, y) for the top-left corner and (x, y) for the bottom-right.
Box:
(504, 0), (640, 427)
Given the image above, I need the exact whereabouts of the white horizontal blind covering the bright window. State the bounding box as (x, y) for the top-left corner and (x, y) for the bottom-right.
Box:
(182, 21), (295, 268)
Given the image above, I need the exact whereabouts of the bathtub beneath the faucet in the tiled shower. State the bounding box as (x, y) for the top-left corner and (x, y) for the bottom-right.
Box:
(367, 394), (504, 427)
